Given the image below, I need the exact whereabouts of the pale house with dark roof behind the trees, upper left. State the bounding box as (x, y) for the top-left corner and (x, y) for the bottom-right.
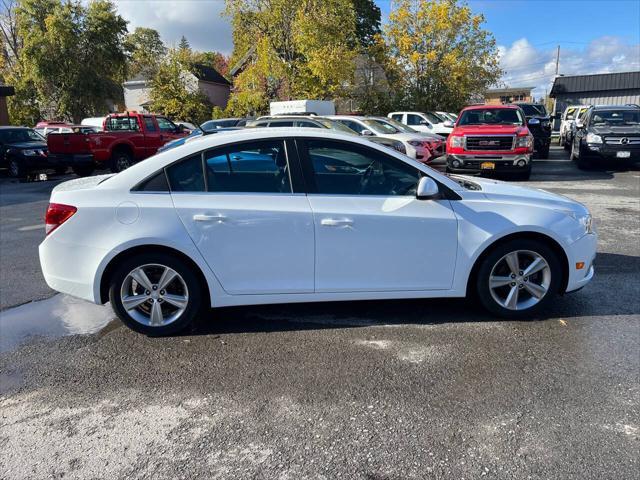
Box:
(122, 64), (231, 112)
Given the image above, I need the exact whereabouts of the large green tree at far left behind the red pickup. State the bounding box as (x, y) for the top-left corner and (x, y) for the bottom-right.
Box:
(6, 0), (127, 122)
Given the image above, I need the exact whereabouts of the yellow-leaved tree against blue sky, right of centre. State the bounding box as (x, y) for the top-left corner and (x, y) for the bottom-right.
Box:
(385, 0), (502, 111)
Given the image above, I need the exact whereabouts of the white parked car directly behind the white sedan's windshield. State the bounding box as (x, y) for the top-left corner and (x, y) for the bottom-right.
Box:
(328, 115), (433, 163)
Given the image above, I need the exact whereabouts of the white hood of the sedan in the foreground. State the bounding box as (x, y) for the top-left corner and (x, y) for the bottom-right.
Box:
(456, 175), (589, 215)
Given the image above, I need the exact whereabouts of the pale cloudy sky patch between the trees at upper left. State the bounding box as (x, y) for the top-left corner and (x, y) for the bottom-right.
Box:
(115, 0), (233, 55)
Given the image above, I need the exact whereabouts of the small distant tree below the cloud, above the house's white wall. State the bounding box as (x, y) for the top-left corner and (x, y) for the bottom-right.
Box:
(125, 27), (167, 78)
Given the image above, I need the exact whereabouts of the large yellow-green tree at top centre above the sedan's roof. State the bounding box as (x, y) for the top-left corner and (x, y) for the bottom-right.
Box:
(227, 0), (357, 115)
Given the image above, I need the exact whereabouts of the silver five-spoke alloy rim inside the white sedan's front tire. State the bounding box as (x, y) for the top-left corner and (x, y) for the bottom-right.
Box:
(489, 250), (551, 310)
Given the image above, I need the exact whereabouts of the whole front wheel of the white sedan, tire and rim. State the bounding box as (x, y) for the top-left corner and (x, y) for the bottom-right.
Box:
(476, 239), (562, 318)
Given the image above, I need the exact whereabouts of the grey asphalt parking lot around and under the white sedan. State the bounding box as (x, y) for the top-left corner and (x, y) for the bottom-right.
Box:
(0, 149), (640, 480)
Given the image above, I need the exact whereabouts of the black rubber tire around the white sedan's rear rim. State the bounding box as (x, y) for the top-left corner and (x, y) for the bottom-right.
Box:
(109, 252), (203, 337)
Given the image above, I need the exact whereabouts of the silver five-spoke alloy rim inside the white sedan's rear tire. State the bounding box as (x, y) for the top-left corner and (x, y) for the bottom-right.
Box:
(120, 263), (189, 327)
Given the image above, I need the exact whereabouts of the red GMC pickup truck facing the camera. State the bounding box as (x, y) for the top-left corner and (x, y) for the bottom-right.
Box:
(447, 105), (533, 179)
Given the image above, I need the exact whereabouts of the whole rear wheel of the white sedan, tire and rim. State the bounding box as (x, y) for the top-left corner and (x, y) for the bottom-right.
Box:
(109, 253), (202, 336)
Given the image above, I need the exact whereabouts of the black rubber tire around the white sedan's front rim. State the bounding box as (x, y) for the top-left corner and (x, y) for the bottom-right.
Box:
(475, 239), (563, 319)
